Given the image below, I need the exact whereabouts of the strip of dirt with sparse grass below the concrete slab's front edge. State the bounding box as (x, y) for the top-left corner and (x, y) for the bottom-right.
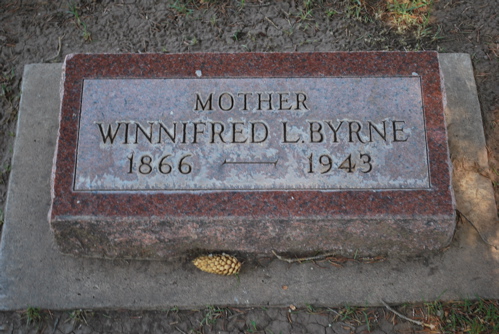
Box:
(0, 300), (499, 334)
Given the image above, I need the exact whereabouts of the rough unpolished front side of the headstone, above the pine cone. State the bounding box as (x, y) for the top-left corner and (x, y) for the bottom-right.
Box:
(52, 214), (456, 260)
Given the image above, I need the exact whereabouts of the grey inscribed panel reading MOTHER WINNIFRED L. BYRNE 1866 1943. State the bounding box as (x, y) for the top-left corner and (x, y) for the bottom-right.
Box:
(74, 76), (429, 191)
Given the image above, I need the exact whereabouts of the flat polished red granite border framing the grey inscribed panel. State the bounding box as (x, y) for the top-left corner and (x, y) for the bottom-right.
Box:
(50, 52), (454, 221)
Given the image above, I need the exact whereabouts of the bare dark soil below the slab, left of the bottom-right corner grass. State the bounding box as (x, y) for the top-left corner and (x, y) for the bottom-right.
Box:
(0, 307), (430, 334)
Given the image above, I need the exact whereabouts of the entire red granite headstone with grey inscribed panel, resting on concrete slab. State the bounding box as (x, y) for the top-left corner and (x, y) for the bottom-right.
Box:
(49, 52), (455, 259)
